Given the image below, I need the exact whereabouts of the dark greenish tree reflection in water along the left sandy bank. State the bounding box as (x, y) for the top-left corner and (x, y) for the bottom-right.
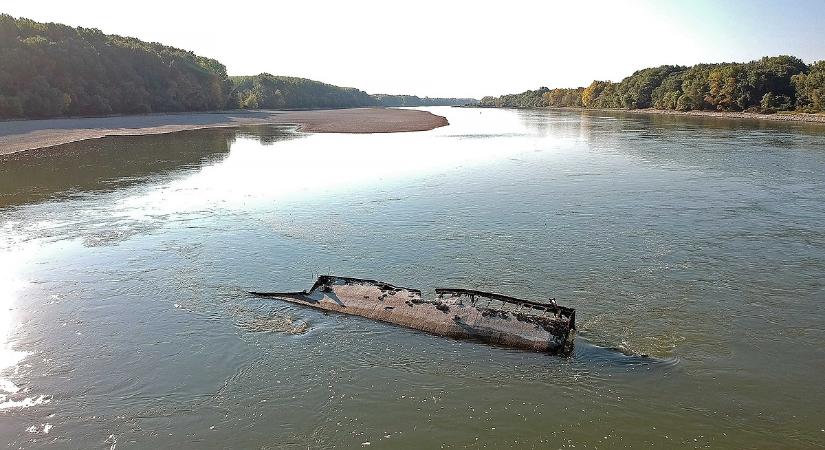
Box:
(0, 126), (297, 208)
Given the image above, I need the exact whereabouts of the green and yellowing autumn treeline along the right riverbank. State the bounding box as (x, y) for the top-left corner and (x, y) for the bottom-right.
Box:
(479, 56), (825, 113)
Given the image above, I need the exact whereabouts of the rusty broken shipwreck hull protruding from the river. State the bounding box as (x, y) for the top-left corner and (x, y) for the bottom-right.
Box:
(250, 275), (576, 355)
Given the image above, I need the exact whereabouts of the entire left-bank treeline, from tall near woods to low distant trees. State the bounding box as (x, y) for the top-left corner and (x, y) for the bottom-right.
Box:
(0, 14), (476, 119)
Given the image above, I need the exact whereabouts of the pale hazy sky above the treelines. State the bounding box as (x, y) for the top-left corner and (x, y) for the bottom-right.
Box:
(0, 0), (825, 98)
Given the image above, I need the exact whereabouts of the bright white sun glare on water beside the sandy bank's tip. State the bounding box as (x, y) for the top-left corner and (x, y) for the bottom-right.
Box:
(115, 121), (560, 217)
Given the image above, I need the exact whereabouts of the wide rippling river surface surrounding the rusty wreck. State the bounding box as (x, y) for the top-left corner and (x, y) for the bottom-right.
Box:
(0, 108), (825, 449)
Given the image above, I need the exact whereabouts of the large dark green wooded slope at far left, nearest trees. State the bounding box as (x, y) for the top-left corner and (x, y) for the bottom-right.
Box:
(0, 14), (231, 118)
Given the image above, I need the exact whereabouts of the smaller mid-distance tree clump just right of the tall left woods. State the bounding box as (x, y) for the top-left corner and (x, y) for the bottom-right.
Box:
(231, 73), (378, 109)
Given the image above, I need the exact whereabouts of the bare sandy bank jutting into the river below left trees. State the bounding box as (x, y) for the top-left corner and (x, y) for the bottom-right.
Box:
(0, 108), (449, 155)
